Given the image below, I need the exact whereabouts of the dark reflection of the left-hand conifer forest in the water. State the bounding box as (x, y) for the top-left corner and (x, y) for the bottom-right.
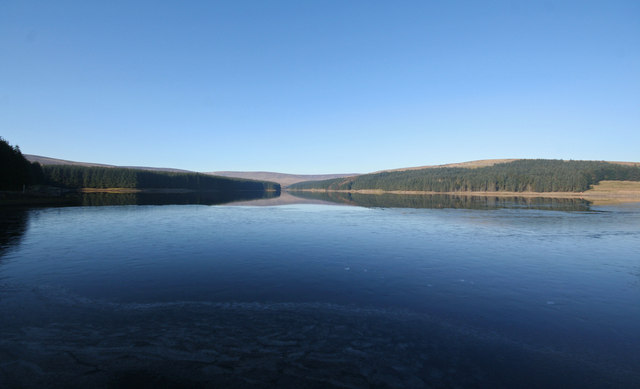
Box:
(80, 191), (278, 206)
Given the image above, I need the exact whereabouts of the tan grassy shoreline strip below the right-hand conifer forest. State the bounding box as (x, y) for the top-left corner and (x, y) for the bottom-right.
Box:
(289, 181), (640, 205)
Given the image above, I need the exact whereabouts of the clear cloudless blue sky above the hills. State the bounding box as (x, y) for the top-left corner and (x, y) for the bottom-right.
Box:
(0, 0), (640, 173)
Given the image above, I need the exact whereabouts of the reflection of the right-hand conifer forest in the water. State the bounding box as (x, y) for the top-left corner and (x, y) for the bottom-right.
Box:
(291, 192), (590, 211)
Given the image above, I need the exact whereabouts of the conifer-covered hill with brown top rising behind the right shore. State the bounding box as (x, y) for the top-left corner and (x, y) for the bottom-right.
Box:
(290, 159), (640, 192)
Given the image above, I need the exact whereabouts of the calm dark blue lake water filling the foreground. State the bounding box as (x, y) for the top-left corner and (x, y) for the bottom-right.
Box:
(0, 197), (640, 388)
